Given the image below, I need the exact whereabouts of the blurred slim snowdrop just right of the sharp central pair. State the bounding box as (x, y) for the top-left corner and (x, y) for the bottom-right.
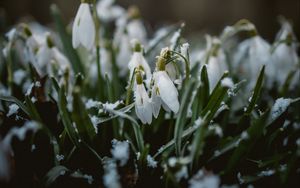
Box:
(206, 38), (227, 92)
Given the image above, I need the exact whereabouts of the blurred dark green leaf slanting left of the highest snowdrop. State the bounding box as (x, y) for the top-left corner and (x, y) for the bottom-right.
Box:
(50, 4), (85, 74)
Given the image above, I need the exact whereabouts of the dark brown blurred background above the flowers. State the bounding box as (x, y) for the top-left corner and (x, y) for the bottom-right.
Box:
(0, 0), (300, 41)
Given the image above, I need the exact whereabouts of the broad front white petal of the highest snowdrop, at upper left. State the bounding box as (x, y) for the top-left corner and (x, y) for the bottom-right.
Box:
(79, 3), (96, 50)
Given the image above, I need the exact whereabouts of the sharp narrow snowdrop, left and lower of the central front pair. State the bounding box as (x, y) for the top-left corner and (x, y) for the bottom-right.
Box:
(134, 70), (152, 124)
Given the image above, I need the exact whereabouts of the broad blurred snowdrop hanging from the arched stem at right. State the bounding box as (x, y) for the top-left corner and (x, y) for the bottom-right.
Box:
(234, 31), (274, 88)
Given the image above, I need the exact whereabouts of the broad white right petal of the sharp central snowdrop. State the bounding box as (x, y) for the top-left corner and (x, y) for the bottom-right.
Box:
(156, 71), (179, 113)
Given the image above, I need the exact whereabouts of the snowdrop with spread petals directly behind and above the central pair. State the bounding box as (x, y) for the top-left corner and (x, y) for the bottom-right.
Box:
(128, 40), (152, 86)
